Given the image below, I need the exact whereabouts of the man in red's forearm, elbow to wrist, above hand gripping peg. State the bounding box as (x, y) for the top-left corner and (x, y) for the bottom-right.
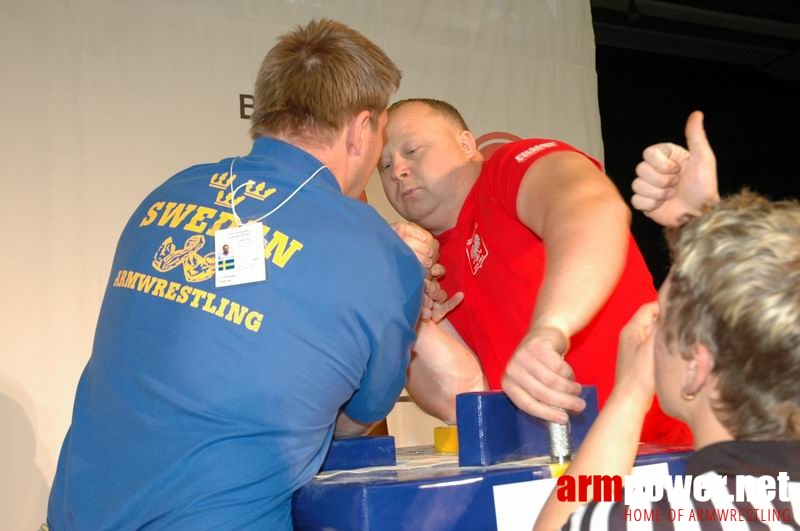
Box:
(531, 194), (630, 335)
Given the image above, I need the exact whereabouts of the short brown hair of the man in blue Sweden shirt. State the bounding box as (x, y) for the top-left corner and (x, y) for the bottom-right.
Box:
(250, 19), (401, 144)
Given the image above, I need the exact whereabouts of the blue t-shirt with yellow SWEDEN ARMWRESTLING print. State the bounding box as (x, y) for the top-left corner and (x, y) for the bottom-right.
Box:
(48, 138), (423, 530)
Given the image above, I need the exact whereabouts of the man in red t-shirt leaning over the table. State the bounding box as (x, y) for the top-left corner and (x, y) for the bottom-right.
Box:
(378, 100), (691, 443)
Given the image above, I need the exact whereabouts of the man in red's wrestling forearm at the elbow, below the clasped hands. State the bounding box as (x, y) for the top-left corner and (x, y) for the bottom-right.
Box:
(406, 321), (487, 424)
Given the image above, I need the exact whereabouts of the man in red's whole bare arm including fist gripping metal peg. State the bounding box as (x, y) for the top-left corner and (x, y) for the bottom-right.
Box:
(503, 152), (630, 422)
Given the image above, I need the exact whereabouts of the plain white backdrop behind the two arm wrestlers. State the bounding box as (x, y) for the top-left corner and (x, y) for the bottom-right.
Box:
(0, 0), (602, 529)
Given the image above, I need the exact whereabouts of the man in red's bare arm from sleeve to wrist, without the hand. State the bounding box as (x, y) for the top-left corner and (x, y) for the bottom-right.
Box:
(517, 152), (630, 335)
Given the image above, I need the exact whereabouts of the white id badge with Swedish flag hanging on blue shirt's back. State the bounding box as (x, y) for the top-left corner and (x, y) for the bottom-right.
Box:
(214, 223), (267, 288)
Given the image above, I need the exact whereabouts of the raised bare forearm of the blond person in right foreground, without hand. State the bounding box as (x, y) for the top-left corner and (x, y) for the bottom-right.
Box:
(534, 303), (658, 531)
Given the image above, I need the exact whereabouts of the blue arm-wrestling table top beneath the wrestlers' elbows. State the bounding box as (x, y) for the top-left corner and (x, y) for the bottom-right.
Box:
(293, 445), (689, 531)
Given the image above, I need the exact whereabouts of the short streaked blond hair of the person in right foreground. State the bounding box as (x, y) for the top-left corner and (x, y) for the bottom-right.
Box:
(663, 191), (800, 440)
